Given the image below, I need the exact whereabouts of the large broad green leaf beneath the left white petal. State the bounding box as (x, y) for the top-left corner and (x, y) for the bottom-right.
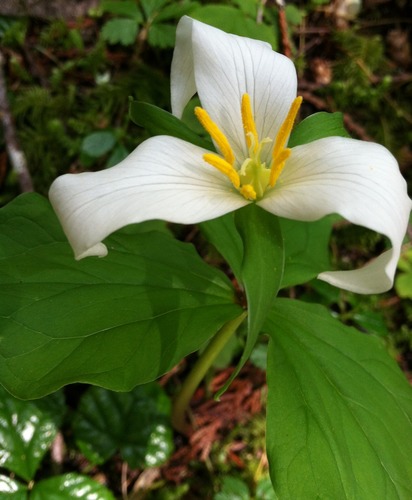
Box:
(0, 195), (240, 398)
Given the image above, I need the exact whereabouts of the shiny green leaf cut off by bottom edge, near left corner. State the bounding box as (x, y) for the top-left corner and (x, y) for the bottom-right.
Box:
(30, 472), (115, 500)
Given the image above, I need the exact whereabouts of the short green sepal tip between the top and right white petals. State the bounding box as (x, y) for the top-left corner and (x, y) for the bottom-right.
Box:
(288, 112), (349, 148)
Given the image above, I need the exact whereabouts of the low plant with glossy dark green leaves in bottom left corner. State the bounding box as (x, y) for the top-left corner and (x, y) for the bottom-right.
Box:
(0, 384), (173, 500)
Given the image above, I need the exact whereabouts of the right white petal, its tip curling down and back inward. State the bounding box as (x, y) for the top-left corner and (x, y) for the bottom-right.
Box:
(258, 137), (412, 293)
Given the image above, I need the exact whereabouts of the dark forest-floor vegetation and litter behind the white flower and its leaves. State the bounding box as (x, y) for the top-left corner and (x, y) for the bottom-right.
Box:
(0, 0), (412, 500)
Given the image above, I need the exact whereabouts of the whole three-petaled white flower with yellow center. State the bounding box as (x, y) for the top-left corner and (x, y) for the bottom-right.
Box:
(50, 17), (411, 293)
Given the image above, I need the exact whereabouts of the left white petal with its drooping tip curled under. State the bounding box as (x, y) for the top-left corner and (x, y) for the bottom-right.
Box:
(49, 136), (248, 259)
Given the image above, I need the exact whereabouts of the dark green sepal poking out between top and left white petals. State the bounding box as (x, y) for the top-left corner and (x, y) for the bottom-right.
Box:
(129, 101), (213, 149)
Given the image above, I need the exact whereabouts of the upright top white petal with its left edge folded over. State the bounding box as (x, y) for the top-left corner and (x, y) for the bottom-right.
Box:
(171, 17), (297, 162)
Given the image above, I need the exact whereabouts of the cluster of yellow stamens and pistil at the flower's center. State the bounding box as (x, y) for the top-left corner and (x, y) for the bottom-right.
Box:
(195, 94), (302, 200)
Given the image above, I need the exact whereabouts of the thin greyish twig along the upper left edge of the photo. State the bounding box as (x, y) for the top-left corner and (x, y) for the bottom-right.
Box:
(0, 51), (34, 193)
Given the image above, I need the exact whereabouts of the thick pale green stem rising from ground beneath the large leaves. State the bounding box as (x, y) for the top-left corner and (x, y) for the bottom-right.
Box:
(172, 311), (247, 434)
